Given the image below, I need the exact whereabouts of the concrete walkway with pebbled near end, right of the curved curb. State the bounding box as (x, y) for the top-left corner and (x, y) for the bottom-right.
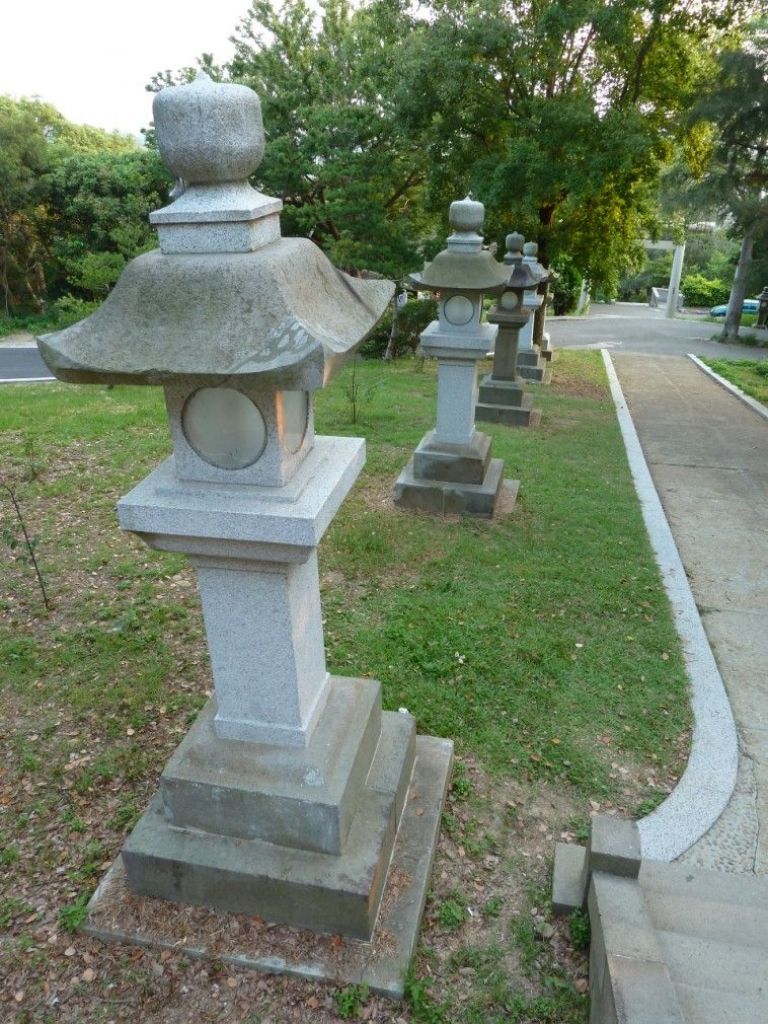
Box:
(612, 350), (768, 874)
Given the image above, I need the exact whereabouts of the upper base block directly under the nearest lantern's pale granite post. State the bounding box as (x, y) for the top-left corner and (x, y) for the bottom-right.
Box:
(160, 677), (382, 853)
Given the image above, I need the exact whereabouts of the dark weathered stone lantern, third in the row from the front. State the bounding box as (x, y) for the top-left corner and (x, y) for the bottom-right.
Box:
(475, 232), (542, 427)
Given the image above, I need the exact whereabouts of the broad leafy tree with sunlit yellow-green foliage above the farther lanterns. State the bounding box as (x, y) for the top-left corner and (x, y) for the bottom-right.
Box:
(387, 0), (750, 290)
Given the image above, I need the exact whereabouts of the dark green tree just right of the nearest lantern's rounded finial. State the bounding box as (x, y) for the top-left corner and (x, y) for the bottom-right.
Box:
(226, 0), (438, 276)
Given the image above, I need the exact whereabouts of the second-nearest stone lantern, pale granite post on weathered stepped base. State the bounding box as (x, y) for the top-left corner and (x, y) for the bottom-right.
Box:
(394, 197), (509, 516)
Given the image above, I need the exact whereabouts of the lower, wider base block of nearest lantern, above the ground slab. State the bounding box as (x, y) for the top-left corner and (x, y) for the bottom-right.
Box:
(122, 712), (434, 939)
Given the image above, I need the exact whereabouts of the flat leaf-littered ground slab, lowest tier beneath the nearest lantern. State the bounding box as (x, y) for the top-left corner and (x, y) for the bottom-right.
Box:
(83, 733), (453, 998)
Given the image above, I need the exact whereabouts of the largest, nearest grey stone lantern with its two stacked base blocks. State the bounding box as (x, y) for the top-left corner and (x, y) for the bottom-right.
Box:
(40, 75), (452, 974)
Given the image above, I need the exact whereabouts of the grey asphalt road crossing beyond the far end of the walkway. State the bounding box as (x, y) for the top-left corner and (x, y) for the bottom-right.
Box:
(547, 302), (768, 359)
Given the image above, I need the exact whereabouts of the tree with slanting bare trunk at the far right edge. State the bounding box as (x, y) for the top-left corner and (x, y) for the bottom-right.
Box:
(690, 20), (768, 341)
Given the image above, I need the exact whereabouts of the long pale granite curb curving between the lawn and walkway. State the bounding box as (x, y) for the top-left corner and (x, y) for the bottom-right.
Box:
(602, 349), (738, 860)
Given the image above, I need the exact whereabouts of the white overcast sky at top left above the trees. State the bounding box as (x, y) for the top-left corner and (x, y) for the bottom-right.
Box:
(0, 0), (259, 134)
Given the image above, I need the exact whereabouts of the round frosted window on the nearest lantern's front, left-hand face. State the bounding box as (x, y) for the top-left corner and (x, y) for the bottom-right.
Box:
(181, 387), (266, 469)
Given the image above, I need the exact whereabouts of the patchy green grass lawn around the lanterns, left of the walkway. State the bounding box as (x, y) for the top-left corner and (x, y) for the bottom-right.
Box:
(0, 352), (690, 1024)
